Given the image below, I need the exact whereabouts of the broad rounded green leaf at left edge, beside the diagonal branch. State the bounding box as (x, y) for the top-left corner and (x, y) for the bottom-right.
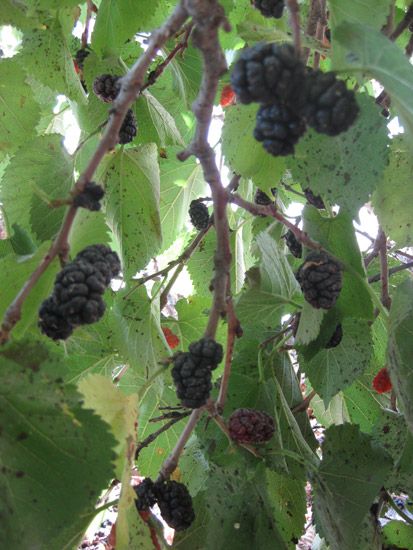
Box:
(1, 134), (73, 242)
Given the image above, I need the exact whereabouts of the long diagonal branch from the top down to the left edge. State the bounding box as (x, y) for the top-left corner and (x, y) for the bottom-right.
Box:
(0, 3), (188, 345)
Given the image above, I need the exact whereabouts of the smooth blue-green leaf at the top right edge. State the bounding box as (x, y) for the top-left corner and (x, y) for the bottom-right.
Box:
(335, 22), (413, 147)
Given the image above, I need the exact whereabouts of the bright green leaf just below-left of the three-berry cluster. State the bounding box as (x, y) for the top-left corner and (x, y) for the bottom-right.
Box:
(222, 104), (285, 193)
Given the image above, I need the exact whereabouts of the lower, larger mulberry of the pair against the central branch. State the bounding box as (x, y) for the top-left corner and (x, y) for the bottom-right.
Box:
(172, 353), (212, 409)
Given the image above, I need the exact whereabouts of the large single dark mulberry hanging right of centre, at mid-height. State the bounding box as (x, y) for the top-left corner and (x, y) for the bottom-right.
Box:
(296, 252), (342, 309)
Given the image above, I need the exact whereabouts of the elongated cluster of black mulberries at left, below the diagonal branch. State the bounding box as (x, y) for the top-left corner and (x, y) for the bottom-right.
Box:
(39, 244), (120, 340)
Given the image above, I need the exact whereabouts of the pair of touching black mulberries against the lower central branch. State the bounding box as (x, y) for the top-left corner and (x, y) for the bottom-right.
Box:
(172, 338), (223, 409)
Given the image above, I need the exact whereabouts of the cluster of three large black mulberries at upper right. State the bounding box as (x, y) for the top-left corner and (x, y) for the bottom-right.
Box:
(231, 42), (359, 161)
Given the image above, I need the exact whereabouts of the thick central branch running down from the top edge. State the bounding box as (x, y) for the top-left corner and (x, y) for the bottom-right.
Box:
(160, 0), (231, 479)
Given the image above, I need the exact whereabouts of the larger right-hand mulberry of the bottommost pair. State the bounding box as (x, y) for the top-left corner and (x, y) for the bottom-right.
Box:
(156, 480), (195, 531)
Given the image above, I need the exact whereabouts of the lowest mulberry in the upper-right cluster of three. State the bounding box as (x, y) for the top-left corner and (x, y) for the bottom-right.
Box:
(254, 103), (306, 156)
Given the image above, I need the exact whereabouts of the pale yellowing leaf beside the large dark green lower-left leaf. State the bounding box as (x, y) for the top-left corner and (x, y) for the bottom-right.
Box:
(77, 374), (138, 479)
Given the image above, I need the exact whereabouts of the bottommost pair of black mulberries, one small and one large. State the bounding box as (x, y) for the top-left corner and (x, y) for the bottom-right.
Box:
(135, 477), (195, 531)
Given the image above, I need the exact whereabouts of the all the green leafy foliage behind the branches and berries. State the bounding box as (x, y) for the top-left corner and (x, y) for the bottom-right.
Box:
(0, 0), (413, 550)
